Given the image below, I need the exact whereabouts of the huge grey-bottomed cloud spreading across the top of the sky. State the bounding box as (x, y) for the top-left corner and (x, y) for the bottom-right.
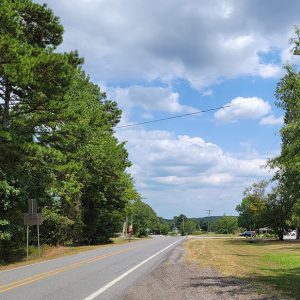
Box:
(38, 0), (300, 89)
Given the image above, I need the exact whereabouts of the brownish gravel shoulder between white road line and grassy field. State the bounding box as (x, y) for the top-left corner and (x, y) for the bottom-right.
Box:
(119, 245), (283, 300)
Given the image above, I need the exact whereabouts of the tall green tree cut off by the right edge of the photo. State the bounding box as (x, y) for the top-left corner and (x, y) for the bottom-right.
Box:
(270, 27), (300, 237)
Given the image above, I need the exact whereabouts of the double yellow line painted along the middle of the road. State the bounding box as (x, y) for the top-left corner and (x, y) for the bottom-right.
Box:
(0, 246), (138, 293)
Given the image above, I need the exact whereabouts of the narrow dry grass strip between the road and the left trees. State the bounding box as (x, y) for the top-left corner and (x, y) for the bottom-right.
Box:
(0, 237), (145, 271)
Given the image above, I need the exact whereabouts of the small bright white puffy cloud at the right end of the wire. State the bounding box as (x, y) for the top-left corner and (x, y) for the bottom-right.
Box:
(214, 97), (271, 123)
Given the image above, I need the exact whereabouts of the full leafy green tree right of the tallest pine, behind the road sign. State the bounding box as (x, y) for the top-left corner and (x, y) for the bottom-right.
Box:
(48, 72), (136, 244)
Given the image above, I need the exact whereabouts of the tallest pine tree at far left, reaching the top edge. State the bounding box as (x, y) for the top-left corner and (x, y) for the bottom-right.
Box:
(0, 0), (80, 261)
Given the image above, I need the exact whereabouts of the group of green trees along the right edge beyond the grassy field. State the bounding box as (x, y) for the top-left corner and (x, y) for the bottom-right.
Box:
(236, 27), (300, 240)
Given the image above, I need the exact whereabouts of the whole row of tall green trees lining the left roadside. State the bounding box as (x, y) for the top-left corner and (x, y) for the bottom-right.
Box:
(0, 0), (168, 263)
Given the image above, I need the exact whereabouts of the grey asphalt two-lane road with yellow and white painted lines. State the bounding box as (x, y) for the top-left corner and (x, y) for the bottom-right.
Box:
(0, 236), (184, 300)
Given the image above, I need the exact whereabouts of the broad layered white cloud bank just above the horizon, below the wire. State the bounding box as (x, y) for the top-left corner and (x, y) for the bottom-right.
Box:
(117, 129), (270, 217)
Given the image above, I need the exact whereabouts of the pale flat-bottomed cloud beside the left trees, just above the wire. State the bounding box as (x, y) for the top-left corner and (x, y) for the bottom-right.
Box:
(111, 86), (196, 113)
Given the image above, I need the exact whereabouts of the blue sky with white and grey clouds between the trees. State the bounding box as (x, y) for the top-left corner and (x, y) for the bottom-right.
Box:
(36, 0), (300, 218)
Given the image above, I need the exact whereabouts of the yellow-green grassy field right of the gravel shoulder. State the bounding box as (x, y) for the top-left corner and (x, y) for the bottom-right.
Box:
(185, 239), (300, 299)
